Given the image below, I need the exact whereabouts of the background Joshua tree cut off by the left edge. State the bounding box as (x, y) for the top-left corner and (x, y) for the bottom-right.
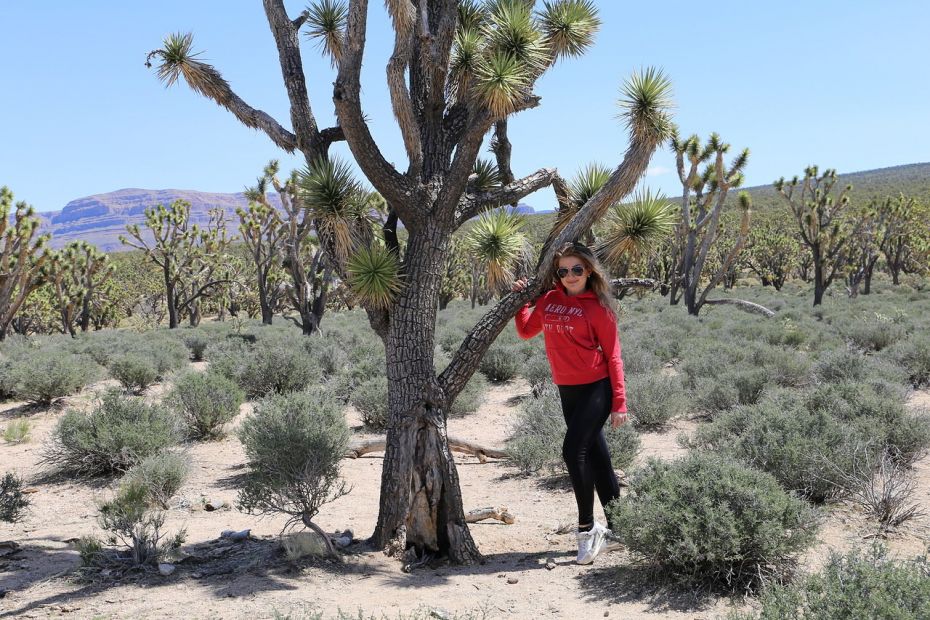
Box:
(0, 185), (49, 340)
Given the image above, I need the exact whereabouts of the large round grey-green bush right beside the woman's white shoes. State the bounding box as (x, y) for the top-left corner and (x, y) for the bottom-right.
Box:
(608, 453), (817, 590)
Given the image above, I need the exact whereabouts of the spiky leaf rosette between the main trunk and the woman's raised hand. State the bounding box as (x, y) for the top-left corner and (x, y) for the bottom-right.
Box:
(466, 209), (526, 290)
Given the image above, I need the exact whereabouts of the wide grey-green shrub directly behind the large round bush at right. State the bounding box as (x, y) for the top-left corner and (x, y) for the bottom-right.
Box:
(690, 392), (868, 501)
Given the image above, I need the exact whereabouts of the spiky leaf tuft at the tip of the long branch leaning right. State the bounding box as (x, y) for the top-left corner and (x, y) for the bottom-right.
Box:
(618, 67), (673, 145)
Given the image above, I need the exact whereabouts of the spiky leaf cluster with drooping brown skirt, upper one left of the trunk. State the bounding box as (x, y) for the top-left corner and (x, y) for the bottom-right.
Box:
(297, 158), (367, 260)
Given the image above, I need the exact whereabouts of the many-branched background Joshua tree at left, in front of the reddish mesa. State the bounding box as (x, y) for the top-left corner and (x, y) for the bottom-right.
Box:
(119, 200), (229, 329)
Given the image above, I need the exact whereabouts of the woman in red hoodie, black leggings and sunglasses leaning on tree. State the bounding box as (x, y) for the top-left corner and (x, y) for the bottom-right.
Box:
(512, 243), (627, 564)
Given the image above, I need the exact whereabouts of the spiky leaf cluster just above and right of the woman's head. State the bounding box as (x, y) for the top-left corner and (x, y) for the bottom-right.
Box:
(596, 188), (678, 265)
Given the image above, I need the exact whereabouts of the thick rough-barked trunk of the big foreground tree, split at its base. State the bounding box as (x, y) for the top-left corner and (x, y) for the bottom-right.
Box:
(372, 223), (481, 564)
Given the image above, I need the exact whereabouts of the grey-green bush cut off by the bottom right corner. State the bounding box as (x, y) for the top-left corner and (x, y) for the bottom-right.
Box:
(727, 545), (930, 620)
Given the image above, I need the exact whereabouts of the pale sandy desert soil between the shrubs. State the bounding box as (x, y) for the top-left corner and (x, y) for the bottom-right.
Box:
(0, 372), (930, 619)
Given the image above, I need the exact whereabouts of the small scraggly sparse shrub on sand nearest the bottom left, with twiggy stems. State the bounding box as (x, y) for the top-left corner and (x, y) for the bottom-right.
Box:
(87, 479), (185, 568)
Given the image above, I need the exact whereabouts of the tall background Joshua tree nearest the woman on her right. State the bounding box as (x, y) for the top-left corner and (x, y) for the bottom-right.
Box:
(669, 133), (751, 316)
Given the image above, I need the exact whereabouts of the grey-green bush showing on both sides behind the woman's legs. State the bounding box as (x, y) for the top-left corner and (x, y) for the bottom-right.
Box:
(507, 386), (640, 475)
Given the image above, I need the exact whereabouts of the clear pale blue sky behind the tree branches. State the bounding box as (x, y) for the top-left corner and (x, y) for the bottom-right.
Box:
(0, 0), (930, 211)
